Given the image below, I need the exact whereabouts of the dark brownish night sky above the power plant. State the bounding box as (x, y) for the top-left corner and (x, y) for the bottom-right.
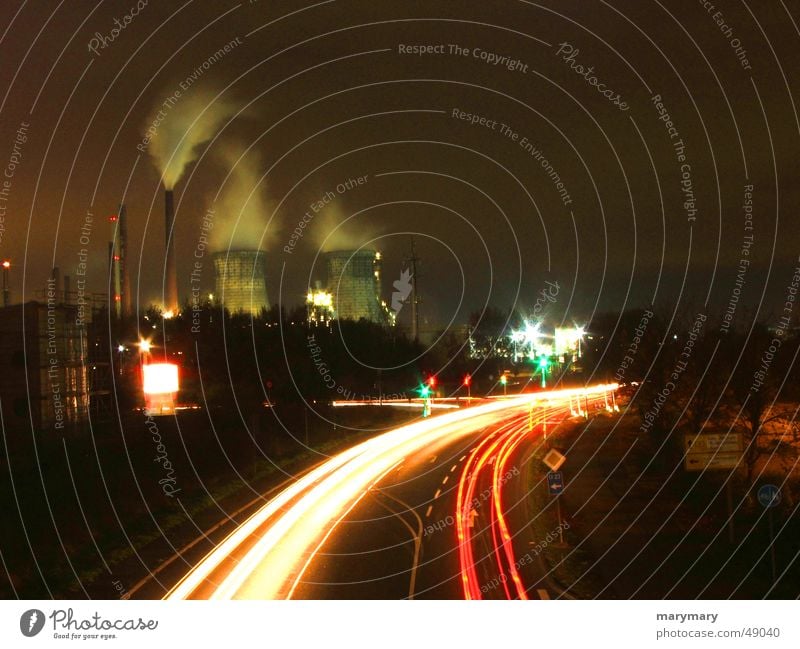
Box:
(0, 0), (800, 324)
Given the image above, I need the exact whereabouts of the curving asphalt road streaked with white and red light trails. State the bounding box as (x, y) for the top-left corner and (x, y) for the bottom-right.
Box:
(167, 385), (616, 599)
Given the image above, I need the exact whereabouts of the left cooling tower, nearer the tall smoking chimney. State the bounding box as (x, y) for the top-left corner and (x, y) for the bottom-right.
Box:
(214, 250), (269, 316)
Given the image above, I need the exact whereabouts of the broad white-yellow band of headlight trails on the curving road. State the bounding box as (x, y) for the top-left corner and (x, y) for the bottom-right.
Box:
(165, 385), (616, 599)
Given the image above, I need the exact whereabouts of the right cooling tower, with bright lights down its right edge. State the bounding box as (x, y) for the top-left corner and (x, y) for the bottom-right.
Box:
(325, 248), (385, 323)
